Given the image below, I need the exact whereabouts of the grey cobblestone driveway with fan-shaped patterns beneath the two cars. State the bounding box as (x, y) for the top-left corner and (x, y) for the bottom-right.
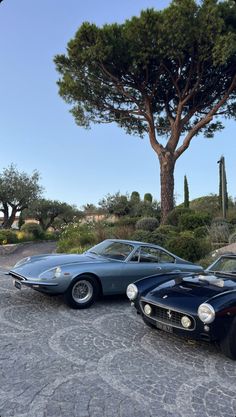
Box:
(0, 242), (236, 417)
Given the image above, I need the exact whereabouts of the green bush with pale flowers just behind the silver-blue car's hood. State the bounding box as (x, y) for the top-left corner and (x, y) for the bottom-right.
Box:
(57, 223), (96, 252)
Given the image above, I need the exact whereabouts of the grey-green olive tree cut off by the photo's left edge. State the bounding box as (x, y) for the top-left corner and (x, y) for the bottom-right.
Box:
(0, 165), (42, 229)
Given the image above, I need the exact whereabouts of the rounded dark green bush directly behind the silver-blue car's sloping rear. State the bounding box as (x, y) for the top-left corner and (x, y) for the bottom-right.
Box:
(166, 234), (211, 262)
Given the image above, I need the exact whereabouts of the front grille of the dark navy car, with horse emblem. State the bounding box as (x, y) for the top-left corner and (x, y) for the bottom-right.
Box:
(141, 301), (195, 330)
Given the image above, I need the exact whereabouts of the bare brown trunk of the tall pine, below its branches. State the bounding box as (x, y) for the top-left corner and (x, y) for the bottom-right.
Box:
(159, 152), (175, 224)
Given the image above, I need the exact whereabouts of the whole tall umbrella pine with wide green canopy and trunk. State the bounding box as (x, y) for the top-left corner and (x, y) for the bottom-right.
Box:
(55, 0), (236, 220)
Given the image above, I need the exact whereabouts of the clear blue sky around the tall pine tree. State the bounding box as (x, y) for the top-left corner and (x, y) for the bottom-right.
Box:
(0, 0), (236, 207)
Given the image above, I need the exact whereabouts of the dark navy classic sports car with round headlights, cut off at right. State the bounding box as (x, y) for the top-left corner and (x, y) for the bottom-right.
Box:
(127, 254), (236, 359)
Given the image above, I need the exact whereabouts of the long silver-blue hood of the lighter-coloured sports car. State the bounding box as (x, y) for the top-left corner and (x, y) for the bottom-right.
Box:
(9, 254), (110, 278)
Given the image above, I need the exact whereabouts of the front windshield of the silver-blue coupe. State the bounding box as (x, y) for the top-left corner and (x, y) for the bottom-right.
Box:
(86, 240), (134, 261)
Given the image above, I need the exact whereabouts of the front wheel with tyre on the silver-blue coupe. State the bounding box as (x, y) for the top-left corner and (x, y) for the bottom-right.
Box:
(65, 275), (99, 309)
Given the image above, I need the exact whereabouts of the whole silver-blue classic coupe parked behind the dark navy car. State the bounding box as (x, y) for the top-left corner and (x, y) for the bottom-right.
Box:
(9, 239), (202, 308)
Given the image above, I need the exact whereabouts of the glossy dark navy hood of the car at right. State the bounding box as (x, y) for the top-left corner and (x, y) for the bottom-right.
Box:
(144, 275), (236, 311)
